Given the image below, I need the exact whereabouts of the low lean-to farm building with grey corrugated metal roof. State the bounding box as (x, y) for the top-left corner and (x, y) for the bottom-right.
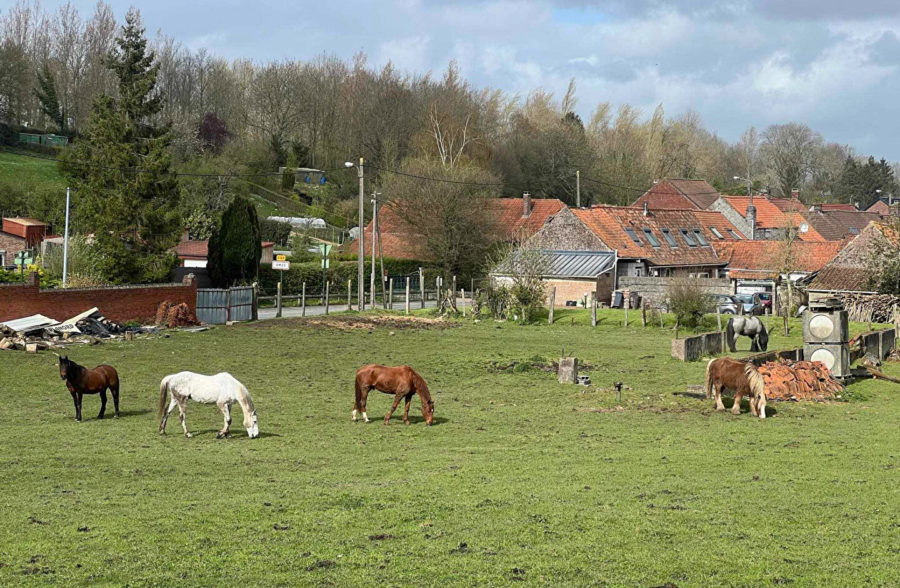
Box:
(491, 250), (616, 306)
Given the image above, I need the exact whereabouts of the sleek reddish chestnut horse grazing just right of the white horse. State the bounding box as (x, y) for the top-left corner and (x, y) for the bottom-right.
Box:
(351, 363), (434, 425)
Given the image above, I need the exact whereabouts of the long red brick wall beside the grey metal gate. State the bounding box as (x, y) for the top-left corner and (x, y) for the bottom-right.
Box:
(0, 274), (197, 322)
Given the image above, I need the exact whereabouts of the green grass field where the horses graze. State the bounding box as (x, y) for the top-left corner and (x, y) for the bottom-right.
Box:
(0, 311), (900, 587)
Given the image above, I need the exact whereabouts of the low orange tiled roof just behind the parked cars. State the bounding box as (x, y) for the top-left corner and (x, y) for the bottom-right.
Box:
(716, 241), (846, 279)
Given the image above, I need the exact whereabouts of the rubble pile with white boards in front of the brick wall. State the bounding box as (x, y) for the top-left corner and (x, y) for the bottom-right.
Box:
(0, 308), (146, 352)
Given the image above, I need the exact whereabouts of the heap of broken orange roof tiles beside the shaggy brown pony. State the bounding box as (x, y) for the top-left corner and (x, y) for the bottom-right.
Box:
(759, 361), (844, 401)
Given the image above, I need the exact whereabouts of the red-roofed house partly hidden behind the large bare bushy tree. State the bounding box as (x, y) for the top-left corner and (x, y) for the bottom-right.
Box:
(356, 196), (566, 261)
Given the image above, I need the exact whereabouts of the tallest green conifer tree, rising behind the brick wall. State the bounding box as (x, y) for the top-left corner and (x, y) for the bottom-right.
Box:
(63, 10), (181, 283)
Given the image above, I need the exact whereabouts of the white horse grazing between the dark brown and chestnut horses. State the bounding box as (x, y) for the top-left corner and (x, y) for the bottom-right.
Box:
(159, 372), (259, 439)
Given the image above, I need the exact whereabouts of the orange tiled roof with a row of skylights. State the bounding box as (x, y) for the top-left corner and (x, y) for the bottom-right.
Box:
(572, 206), (740, 266)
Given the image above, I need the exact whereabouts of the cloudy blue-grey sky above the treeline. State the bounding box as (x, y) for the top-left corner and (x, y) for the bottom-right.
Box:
(59, 0), (900, 161)
